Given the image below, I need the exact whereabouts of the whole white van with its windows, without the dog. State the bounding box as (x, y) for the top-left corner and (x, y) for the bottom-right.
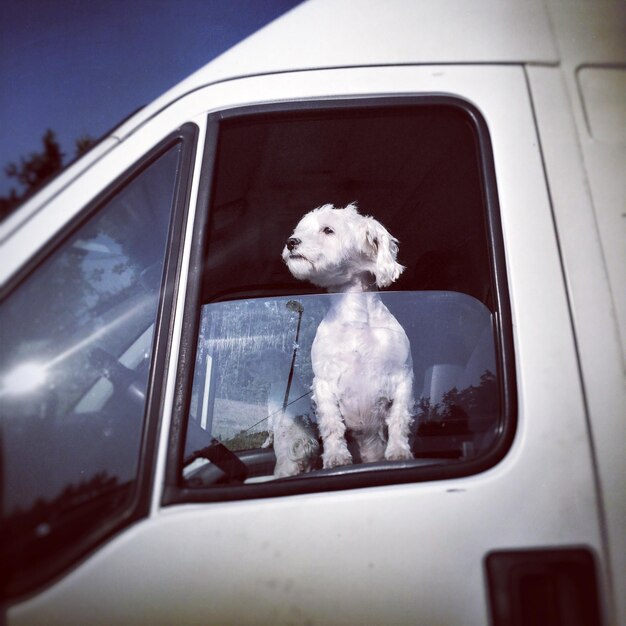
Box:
(0, 0), (626, 626)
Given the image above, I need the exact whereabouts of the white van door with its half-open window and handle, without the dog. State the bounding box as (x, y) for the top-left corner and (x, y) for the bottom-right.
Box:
(2, 66), (604, 625)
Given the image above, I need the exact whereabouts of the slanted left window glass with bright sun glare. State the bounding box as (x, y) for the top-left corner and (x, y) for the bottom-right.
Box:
(0, 144), (181, 584)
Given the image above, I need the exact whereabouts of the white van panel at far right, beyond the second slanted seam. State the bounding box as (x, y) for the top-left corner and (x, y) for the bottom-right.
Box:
(544, 2), (626, 359)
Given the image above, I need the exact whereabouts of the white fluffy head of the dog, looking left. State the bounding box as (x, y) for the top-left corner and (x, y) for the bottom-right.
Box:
(282, 204), (404, 288)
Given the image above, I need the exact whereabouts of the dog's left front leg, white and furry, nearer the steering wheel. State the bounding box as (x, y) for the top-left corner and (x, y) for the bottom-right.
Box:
(313, 378), (352, 469)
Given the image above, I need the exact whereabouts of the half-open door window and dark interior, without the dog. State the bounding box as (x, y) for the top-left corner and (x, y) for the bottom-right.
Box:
(166, 97), (514, 501)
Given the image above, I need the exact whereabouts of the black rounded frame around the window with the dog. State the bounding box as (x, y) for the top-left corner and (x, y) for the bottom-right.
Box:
(162, 93), (517, 506)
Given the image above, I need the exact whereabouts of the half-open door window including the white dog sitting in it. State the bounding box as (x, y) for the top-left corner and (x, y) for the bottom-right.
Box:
(172, 97), (514, 501)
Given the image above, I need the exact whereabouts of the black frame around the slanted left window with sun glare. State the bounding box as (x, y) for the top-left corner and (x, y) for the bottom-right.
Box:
(0, 123), (199, 599)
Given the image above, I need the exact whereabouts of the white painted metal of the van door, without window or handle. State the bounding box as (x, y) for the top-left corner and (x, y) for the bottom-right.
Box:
(9, 66), (603, 626)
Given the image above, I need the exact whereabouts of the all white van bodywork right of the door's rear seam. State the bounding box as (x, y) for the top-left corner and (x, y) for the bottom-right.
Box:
(528, 2), (626, 608)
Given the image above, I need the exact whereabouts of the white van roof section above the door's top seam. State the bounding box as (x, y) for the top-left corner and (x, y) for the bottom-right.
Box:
(116, 0), (559, 137)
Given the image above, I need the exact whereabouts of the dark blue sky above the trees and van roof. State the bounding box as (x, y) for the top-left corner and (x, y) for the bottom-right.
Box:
(0, 0), (301, 194)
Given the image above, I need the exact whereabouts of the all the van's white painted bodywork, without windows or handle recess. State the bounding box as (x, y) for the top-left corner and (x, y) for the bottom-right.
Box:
(0, 0), (626, 626)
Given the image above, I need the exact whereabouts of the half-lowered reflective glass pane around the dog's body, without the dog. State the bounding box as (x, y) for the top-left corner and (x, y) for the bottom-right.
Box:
(185, 291), (499, 484)
